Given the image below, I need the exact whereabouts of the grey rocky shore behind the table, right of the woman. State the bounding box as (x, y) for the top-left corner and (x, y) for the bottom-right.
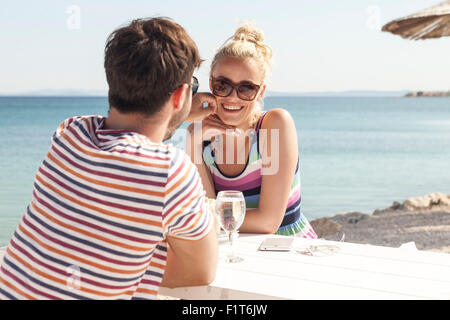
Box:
(310, 193), (450, 253)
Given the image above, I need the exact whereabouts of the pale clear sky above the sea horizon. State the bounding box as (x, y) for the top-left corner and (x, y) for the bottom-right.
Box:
(0, 0), (450, 94)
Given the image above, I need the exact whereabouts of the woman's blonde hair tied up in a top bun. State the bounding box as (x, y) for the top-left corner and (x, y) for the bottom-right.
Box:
(210, 22), (272, 125)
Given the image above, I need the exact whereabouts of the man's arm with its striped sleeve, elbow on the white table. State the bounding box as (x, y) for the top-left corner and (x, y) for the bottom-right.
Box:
(161, 149), (218, 288)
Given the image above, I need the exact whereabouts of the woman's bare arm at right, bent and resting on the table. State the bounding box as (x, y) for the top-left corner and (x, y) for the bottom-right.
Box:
(239, 109), (298, 233)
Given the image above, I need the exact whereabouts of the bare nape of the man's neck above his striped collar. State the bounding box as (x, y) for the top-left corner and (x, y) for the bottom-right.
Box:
(103, 107), (168, 143)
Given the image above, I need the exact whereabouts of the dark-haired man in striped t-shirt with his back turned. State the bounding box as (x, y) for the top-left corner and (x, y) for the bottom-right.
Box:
(0, 18), (218, 299)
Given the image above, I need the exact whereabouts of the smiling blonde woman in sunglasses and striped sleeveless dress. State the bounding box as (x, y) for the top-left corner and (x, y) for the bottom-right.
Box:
(188, 23), (317, 238)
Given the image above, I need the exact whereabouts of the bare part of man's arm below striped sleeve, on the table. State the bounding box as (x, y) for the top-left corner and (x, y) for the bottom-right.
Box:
(161, 228), (218, 288)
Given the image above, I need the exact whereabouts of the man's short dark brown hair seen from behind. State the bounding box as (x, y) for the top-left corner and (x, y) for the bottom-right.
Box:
(105, 18), (202, 116)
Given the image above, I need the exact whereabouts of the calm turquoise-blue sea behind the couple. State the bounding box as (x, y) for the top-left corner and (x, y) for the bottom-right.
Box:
(0, 97), (450, 246)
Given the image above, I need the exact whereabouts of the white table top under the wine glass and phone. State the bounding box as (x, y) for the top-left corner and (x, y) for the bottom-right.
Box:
(0, 234), (450, 300)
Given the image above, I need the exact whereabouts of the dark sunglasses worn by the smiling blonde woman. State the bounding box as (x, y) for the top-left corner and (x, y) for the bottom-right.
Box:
(211, 77), (261, 101)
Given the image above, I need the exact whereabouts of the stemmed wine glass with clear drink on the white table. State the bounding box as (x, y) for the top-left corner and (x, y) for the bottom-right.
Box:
(216, 190), (245, 263)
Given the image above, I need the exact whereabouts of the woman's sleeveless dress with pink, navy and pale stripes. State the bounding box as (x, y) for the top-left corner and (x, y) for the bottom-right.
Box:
(203, 113), (317, 239)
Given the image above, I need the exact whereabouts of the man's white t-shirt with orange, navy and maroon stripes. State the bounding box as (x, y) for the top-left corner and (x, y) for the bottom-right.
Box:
(0, 116), (211, 299)
